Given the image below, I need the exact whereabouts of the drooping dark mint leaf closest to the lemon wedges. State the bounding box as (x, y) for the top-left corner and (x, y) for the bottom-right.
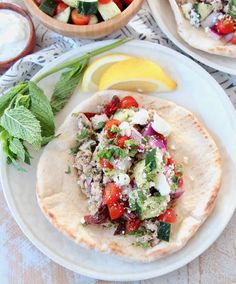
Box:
(51, 61), (88, 114)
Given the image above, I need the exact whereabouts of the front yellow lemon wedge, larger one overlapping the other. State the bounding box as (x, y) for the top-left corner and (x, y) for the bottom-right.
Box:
(99, 58), (177, 93)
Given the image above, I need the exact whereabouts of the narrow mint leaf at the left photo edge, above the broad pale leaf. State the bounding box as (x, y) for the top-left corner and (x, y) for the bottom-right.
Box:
(0, 82), (28, 117)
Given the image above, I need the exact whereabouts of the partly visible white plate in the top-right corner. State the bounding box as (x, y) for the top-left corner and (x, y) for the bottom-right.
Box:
(147, 0), (236, 75)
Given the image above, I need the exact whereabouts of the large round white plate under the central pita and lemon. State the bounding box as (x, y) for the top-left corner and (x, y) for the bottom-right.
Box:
(0, 41), (236, 281)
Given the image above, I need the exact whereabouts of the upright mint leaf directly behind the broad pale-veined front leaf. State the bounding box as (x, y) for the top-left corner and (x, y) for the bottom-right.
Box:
(29, 82), (55, 137)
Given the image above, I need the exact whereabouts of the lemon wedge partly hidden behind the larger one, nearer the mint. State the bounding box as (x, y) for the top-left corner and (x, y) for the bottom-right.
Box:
(82, 54), (132, 92)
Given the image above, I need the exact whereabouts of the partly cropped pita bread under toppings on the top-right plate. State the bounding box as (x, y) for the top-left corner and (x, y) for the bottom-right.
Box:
(169, 0), (236, 57)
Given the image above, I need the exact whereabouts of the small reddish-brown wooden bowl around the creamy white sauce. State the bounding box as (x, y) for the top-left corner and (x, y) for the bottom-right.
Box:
(0, 2), (36, 71)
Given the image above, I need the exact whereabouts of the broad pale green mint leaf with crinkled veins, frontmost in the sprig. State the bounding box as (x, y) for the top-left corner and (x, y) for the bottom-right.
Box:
(0, 106), (42, 149)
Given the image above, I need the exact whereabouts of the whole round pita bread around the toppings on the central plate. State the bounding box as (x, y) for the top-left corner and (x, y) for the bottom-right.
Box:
(37, 91), (221, 262)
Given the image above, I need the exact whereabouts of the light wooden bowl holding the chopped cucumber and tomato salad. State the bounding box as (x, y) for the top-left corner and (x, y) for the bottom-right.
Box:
(24, 0), (143, 39)
